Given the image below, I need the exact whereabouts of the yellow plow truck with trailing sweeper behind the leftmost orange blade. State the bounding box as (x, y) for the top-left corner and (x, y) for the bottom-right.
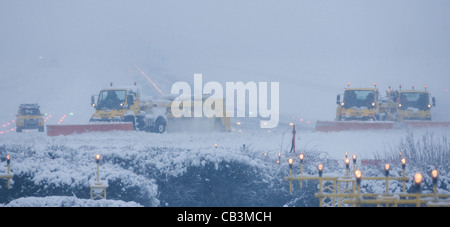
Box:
(90, 88), (230, 133)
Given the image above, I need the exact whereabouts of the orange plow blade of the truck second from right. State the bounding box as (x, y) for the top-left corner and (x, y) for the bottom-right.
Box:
(316, 121), (394, 132)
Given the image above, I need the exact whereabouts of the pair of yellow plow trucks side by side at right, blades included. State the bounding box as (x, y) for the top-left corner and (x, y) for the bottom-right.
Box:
(316, 83), (450, 131)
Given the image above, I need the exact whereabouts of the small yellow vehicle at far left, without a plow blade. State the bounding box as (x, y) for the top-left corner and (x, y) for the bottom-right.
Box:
(16, 103), (44, 132)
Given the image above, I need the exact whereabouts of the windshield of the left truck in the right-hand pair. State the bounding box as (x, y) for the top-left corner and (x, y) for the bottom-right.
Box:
(344, 90), (375, 108)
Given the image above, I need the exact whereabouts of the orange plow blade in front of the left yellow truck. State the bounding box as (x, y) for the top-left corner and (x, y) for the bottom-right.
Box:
(47, 122), (133, 136)
